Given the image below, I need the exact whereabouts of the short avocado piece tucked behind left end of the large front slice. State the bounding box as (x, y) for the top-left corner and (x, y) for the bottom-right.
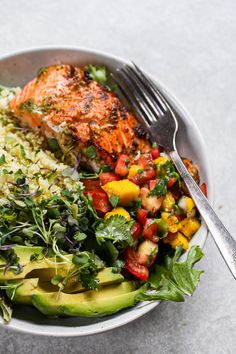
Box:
(6, 278), (59, 305)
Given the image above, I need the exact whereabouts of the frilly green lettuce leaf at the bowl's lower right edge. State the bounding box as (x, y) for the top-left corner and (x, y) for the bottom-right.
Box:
(138, 245), (204, 301)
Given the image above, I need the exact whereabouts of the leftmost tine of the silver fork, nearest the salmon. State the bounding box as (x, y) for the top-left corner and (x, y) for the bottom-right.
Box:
(111, 71), (150, 128)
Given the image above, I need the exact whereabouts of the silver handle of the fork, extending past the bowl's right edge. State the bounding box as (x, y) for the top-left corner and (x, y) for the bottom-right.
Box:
(170, 150), (236, 279)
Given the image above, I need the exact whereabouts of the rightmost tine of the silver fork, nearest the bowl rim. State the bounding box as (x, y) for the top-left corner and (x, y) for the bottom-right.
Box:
(131, 62), (170, 112)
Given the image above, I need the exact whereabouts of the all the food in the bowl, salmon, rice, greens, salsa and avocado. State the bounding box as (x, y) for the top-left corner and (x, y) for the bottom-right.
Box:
(0, 65), (206, 322)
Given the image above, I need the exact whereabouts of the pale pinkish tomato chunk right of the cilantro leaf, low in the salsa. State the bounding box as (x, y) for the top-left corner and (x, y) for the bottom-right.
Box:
(137, 240), (158, 267)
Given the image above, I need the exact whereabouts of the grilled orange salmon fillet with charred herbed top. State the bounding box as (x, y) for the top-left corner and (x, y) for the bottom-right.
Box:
(10, 65), (150, 171)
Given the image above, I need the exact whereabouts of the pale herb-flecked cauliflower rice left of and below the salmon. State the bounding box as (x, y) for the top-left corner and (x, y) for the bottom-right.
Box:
(0, 87), (80, 204)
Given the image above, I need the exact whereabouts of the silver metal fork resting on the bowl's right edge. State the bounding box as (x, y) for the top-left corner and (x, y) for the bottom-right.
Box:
(113, 63), (236, 279)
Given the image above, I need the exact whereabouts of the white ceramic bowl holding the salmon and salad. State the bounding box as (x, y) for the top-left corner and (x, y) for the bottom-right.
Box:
(0, 47), (212, 337)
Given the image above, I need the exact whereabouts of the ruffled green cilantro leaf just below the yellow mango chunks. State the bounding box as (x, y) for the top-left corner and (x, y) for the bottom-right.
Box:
(95, 215), (134, 247)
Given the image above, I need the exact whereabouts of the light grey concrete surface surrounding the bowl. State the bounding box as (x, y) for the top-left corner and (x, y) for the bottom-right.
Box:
(0, 0), (236, 354)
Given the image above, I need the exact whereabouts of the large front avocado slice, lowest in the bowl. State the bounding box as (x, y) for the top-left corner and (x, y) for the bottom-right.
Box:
(32, 282), (140, 317)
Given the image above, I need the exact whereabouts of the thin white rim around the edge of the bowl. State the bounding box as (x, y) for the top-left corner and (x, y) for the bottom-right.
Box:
(0, 44), (214, 337)
